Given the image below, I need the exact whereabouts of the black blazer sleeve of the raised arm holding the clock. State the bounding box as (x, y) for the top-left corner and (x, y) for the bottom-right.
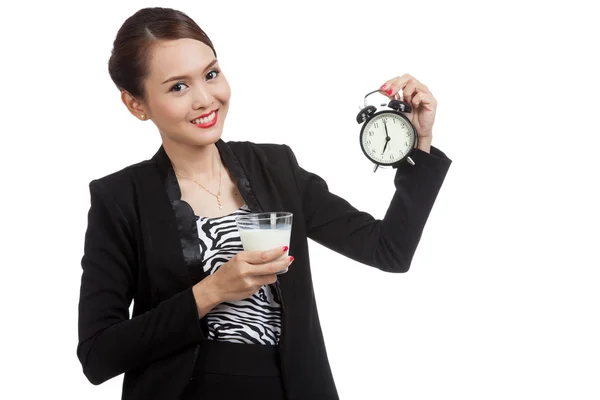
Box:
(284, 145), (452, 272)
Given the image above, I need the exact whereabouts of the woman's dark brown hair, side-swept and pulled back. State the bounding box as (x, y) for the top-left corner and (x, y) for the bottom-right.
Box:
(108, 7), (217, 101)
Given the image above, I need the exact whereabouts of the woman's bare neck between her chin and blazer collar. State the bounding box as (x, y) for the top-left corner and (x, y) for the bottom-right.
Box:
(163, 142), (221, 182)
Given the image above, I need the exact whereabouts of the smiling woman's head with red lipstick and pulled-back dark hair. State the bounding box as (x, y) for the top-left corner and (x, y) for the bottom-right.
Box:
(109, 9), (231, 156)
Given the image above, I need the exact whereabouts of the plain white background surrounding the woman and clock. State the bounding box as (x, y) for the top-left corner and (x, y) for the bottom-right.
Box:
(0, 0), (600, 400)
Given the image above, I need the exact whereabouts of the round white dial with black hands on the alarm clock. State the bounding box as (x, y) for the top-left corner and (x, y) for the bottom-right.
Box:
(360, 112), (415, 165)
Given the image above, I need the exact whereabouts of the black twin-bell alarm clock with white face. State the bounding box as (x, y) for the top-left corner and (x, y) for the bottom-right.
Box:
(356, 89), (418, 172)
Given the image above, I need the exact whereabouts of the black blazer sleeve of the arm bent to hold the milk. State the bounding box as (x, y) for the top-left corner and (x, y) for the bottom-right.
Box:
(77, 181), (204, 385)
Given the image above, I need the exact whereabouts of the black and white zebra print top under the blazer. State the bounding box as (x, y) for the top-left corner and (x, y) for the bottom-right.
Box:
(196, 204), (281, 345)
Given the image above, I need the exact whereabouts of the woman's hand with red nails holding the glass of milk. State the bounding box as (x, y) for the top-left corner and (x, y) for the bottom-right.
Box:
(194, 247), (294, 312)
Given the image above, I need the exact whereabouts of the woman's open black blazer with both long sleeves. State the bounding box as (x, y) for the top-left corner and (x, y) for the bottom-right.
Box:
(77, 140), (451, 400)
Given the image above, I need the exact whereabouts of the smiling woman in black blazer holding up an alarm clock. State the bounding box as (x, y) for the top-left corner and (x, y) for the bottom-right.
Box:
(77, 8), (451, 400)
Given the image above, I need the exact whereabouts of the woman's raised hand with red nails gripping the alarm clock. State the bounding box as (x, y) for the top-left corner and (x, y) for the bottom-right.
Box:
(381, 74), (437, 144)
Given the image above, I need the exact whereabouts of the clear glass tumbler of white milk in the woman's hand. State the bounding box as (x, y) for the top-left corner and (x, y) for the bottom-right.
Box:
(235, 212), (293, 275)
